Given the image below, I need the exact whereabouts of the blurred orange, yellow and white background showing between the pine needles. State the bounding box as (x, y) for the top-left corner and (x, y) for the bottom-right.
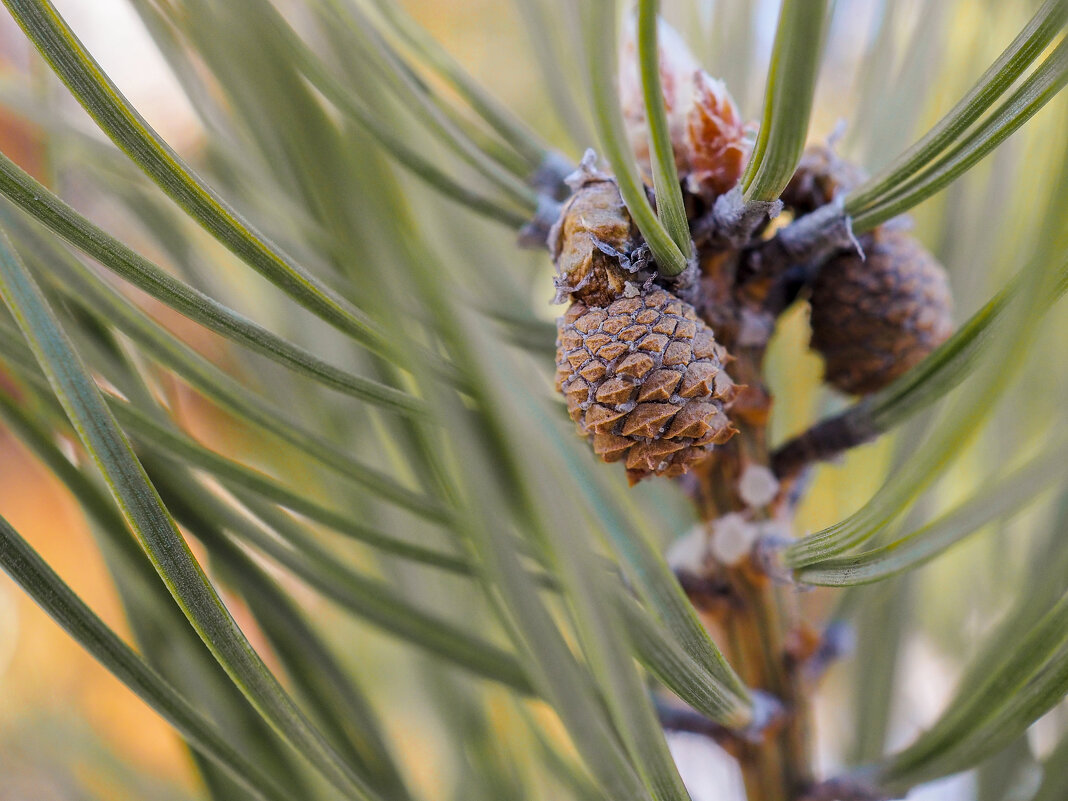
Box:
(0, 0), (1068, 801)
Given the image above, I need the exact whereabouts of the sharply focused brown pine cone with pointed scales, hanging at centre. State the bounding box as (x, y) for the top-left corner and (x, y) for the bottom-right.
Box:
(556, 287), (738, 484)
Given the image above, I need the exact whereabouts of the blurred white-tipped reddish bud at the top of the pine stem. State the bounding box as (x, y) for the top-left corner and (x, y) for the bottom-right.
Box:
(619, 20), (754, 201)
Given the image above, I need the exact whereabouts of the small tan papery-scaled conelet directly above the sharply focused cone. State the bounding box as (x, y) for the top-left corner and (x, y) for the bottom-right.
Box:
(549, 174), (640, 305)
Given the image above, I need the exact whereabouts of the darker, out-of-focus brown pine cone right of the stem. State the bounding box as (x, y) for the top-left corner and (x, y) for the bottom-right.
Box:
(811, 229), (953, 395)
